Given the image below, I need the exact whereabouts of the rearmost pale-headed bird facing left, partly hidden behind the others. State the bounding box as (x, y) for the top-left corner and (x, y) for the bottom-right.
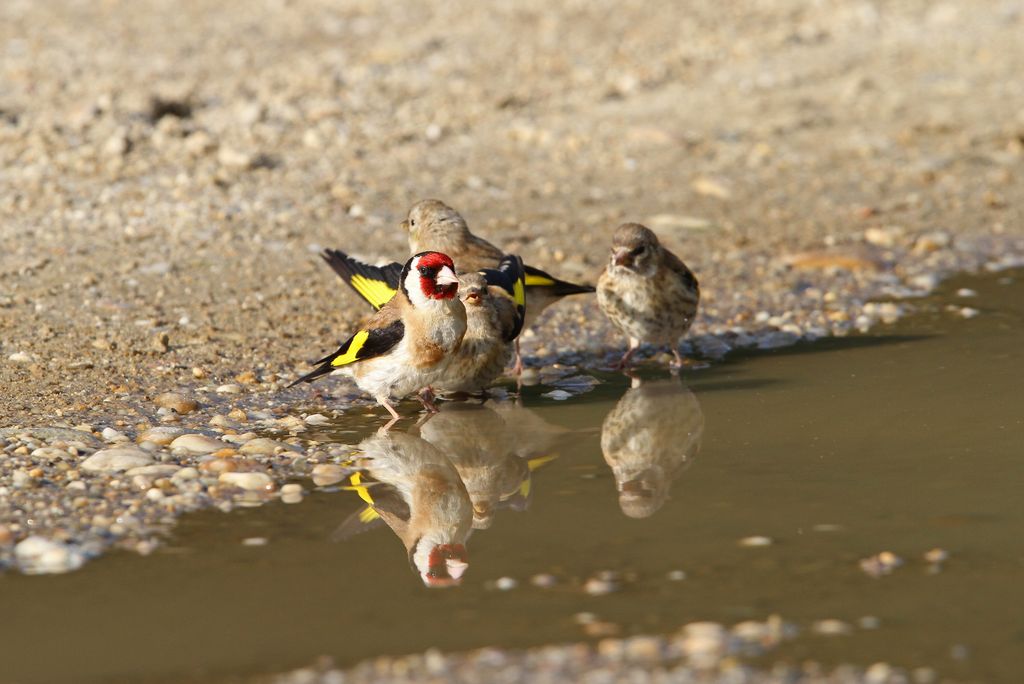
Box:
(401, 200), (594, 370)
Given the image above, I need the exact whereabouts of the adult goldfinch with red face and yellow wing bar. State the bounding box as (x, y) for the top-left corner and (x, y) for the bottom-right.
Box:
(292, 252), (466, 426)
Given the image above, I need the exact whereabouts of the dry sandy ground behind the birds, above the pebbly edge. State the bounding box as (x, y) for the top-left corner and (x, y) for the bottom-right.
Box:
(0, 0), (1024, 425)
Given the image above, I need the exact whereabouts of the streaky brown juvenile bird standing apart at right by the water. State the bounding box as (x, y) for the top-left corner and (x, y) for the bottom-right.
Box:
(597, 223), (700, 368)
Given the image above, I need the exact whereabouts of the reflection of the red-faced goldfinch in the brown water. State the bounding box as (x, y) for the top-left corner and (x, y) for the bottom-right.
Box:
(335, 432), (473, 587)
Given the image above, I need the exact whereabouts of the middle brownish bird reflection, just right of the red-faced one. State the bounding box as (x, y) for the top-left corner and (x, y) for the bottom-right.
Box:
(419, 402), (555, 529)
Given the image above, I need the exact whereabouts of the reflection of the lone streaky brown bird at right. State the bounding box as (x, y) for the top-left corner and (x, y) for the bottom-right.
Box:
(601, 380), (703, 518)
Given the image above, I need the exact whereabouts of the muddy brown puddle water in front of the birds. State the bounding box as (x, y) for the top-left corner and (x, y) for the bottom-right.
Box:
(0, 272), (1024, 682)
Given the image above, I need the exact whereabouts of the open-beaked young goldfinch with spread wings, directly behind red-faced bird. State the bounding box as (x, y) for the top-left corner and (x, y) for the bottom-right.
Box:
(321, 250), (525, 393)
